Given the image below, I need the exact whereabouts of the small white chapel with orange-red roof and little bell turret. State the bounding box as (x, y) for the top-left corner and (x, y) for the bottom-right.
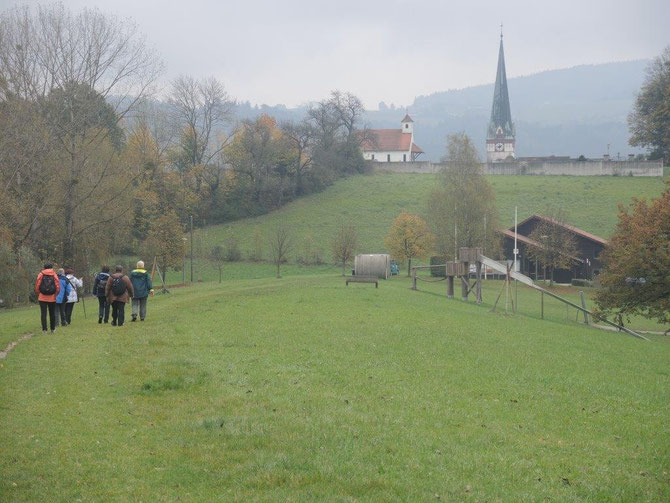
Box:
(361, 115), (423, 162)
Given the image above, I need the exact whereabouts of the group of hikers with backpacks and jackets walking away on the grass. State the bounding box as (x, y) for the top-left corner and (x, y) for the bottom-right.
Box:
(35, 260), (154, 333)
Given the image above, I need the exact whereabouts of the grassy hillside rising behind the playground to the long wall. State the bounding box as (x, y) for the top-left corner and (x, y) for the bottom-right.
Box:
(199, 174), (664, 258)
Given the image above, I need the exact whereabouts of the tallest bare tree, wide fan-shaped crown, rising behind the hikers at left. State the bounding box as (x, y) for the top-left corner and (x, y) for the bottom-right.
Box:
(0, 4), (162, 268)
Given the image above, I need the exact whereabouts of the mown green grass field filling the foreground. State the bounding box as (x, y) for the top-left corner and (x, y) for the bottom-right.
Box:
(0, 274), (670, 502)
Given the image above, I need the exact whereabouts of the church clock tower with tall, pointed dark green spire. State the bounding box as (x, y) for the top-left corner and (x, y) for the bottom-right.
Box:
(486, 32), (516, 163)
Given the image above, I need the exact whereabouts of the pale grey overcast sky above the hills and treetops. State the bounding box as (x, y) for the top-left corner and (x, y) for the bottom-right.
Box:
(0, 0), (670, 109)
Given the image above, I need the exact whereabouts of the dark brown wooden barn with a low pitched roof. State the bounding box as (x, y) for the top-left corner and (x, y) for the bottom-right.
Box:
(501, 215), (607, 283)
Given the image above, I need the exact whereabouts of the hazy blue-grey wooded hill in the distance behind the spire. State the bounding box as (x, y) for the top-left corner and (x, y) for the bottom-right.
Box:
(237, 60), (649, 161)
